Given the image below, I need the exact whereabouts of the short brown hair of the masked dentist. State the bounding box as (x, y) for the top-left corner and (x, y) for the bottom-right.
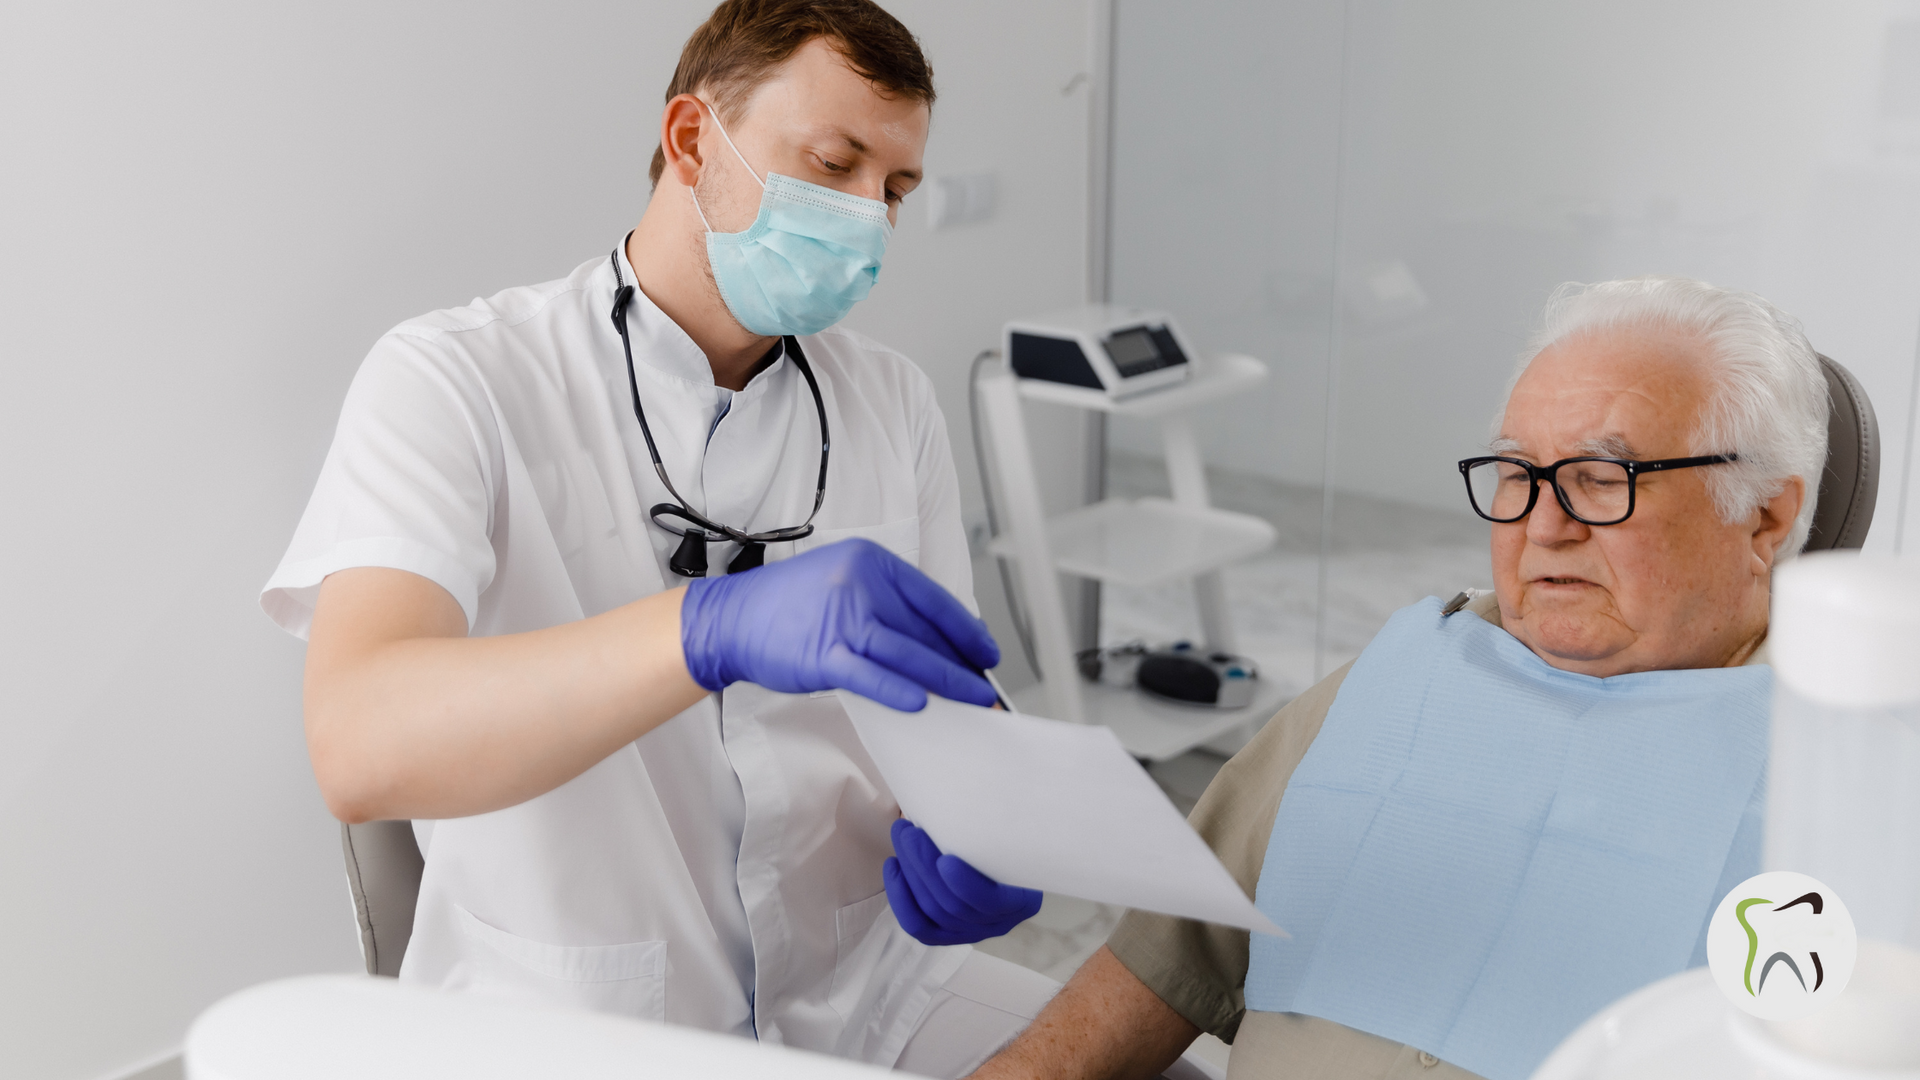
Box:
(649, 0), (933, 184)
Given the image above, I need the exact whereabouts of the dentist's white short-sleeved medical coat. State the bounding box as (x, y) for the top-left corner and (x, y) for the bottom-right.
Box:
(261, 244), (972, 1065)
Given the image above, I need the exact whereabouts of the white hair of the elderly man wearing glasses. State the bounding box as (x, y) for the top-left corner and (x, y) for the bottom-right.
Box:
(1507, 277), (1828, 561)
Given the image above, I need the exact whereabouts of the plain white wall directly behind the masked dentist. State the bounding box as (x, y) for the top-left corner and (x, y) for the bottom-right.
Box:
(0, 0), (1085, 1078)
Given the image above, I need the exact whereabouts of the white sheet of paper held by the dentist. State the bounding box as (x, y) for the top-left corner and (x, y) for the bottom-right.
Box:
(841, 692), (1284, 936)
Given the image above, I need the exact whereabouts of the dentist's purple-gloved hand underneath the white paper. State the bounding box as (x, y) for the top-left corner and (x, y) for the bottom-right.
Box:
(879, 817), (1043, 945)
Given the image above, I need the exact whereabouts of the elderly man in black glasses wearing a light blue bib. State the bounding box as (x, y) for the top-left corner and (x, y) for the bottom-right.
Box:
(975, 279), (1826, 1080)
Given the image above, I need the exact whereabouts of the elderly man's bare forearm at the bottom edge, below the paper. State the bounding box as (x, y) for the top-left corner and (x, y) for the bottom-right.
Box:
(973, 945), (1200, 1080)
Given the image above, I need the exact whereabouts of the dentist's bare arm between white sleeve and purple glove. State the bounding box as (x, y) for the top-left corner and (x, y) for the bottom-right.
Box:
(305, 569), (705, 821)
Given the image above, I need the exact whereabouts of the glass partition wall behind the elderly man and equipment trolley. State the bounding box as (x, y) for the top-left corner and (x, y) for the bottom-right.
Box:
(1102, 0), (1920, 692)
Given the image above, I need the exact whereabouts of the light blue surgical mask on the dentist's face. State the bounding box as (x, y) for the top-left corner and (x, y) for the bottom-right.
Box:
(687, 110), (893, 336)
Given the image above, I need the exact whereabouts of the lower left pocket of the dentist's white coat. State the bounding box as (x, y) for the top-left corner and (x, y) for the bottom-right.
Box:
(447, 907), (666, 1020)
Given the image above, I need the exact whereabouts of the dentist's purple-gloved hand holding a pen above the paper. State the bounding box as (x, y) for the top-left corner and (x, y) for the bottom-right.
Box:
(680, 540), (1000, 713)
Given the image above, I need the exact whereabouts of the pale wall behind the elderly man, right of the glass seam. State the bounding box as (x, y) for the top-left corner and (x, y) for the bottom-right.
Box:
(1336, 0), (1920, 546)
